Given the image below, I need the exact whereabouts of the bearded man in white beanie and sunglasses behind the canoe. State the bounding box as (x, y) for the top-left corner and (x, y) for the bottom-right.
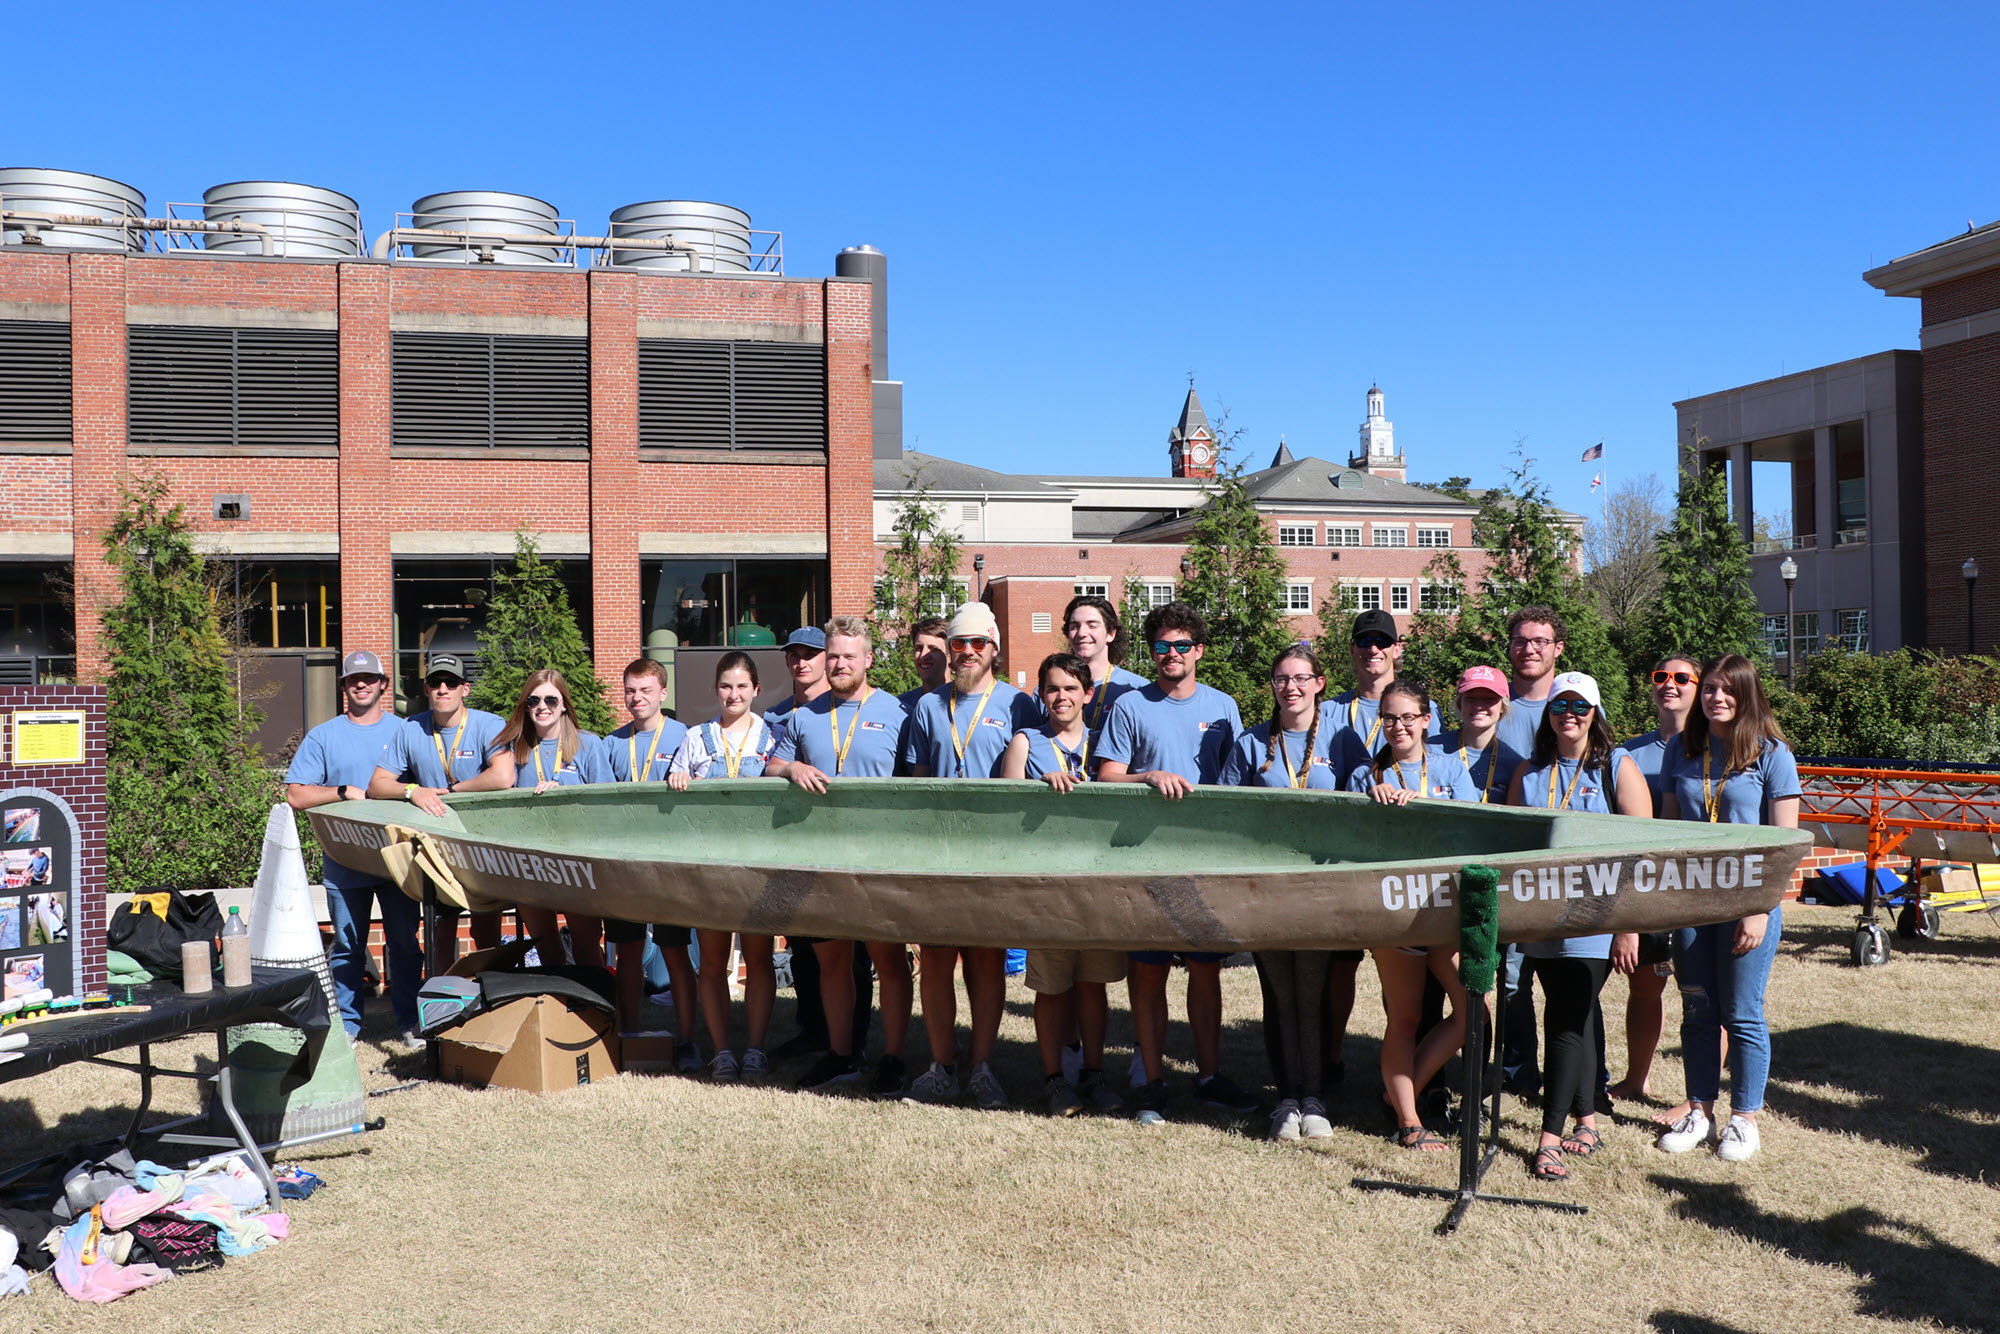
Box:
(902, 602), (1042, 1108)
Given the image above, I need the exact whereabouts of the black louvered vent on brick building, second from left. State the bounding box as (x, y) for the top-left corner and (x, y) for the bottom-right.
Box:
(126, 324), (340, 448)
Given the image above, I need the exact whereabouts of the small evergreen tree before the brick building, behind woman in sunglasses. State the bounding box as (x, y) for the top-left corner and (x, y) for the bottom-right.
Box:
(466, 528), (618, 734)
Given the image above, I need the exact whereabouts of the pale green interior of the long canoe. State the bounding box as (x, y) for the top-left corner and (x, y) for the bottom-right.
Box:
(386, 778), (1778, 876)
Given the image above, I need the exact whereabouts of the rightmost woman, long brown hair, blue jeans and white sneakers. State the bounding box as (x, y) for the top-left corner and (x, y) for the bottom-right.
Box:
(1660, 654), (1802, 1162)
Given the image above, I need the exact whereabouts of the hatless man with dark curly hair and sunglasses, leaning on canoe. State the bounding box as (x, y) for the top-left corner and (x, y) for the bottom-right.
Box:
(1098, 602), (1262, 1124)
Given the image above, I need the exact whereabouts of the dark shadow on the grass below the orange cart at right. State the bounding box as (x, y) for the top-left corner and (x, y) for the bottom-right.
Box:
(1766, 1022), (2000, 1180)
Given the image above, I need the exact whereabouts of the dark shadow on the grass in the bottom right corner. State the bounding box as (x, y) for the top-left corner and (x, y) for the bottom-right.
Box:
(1652, 1174), (2000, 1332)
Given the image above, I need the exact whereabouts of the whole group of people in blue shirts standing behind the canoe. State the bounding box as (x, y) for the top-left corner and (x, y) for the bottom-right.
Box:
(288, 596), (1800, 1180)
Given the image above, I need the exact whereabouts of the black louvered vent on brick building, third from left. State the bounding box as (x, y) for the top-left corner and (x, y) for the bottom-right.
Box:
(392, 334), (590, 448)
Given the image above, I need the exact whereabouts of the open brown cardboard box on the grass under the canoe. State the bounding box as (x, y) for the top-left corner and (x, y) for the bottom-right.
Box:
(438, 996), (618, 1094)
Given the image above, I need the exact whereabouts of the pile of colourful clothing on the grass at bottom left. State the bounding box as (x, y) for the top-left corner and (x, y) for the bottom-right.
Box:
(0, 1150), (320, 1302)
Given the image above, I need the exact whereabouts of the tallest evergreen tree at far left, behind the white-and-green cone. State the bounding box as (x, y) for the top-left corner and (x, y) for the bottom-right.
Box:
(102, 474), (282, 892)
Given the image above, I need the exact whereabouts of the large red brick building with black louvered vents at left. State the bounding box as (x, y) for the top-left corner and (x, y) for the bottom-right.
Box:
(0, 193), (878, 744)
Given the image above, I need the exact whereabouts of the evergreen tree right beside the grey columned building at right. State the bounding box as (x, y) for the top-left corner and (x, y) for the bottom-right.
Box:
(1632, 468), (1766, 672)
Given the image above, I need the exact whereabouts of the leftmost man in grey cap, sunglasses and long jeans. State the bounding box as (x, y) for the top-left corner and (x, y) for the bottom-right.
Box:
(284, 650), (424, 1044)
